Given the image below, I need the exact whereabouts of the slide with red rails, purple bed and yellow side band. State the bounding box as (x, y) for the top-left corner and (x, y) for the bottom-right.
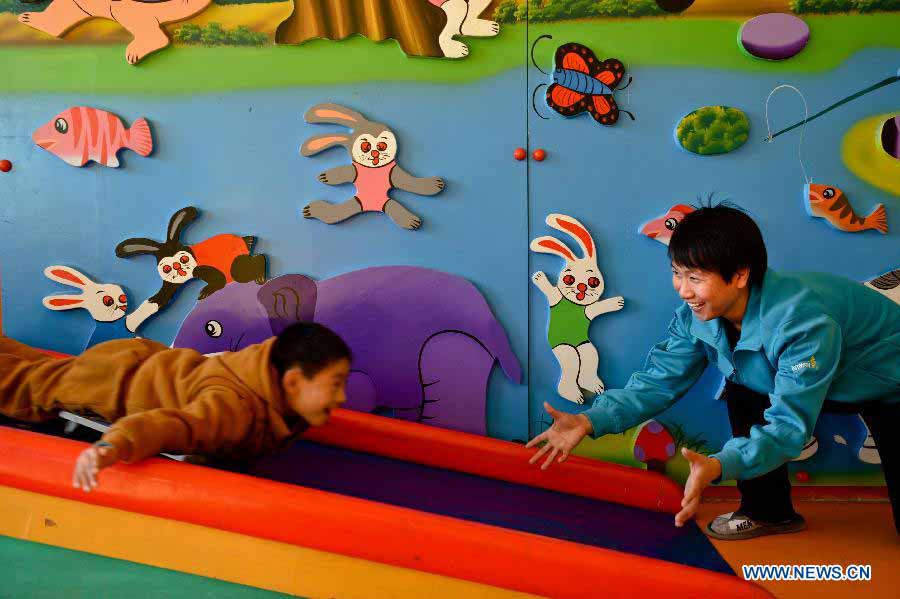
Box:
(0, 400), (770, 598)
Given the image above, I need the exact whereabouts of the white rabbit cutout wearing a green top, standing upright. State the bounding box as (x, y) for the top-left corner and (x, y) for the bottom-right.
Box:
(530, 214), (625, 404)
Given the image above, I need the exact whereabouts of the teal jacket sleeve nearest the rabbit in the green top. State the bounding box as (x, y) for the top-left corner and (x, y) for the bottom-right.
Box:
(584, 314), (708, 438)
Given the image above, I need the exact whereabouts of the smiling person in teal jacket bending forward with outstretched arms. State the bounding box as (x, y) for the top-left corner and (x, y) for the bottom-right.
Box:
(528, 205), (900, 539)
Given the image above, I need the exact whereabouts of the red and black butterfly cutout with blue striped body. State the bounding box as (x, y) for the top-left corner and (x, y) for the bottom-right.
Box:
(531, 35), (634, 125)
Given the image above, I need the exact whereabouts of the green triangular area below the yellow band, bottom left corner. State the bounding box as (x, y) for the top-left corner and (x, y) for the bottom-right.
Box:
(0, 536), (290, 599)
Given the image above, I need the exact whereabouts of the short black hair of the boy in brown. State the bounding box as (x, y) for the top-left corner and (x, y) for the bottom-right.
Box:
(269, 322), (351, 379)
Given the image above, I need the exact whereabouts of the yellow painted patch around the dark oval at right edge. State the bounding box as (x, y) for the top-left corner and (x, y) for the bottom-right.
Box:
(841, 110), (900, 196)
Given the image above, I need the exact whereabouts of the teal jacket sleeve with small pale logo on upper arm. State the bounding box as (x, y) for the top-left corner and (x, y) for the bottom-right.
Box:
(711, 314), (841, 481)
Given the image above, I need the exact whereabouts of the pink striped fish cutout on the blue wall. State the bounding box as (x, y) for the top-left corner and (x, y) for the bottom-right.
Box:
(31, 106), (153, 168)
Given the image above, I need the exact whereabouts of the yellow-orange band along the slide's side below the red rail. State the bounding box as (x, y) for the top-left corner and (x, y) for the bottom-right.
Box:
(0, 486), (535, 599)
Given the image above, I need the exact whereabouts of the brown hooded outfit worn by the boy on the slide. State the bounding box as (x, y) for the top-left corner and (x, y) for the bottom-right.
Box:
(0, 337), (306, 462)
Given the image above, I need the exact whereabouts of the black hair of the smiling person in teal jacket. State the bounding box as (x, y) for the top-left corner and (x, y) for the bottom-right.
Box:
(669, 203), (768, 285)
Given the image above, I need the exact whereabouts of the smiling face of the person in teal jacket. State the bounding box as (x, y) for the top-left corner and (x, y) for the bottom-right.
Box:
(672, 263), (750, 323)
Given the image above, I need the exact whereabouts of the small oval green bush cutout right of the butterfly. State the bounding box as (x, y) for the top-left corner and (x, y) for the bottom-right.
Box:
(675, 106), (750, 156)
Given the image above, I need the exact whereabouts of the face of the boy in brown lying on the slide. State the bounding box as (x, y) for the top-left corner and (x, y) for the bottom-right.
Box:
(281, 360), (350, 426)
